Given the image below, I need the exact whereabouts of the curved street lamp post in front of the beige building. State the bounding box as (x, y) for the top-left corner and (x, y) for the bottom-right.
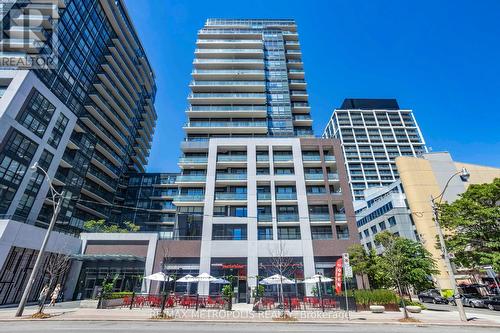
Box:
(431, 168), (470, 321)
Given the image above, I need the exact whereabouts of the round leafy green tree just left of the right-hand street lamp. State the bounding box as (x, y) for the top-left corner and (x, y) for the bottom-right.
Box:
(375, 231), (437, 318)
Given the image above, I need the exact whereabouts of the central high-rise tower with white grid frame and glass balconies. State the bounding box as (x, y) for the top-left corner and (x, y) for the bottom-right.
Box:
(171, 19), (357, 300)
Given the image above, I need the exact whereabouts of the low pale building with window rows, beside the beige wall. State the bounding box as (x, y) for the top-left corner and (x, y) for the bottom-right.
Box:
(354, 180), (420, 253)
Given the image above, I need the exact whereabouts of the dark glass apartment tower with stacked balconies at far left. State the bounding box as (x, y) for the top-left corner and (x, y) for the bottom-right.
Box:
(0, 0), (157, 304)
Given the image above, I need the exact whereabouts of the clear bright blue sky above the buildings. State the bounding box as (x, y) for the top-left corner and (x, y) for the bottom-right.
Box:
(125, 0), (500, 172)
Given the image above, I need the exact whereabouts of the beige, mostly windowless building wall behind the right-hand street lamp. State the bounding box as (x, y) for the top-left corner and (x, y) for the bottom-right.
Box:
(396, 152), (500, 289)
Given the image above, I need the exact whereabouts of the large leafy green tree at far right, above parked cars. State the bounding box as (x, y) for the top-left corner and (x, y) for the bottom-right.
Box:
(438, 178), (500, 272)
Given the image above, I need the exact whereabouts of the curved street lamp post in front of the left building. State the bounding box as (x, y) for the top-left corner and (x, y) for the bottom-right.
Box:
(16, 162), (65, 317)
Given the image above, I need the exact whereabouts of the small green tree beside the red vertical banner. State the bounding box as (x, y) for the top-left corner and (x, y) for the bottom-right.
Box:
(347, 244), (380, 289)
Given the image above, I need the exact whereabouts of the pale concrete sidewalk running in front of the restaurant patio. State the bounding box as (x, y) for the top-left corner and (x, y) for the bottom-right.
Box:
(0, 303), (500, 328)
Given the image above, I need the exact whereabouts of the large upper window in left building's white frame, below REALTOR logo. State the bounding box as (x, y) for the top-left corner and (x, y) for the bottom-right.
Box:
(17, 89), (56, 138)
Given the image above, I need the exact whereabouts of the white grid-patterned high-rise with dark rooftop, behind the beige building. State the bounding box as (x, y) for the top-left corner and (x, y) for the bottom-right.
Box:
(323, 99), (427, 200)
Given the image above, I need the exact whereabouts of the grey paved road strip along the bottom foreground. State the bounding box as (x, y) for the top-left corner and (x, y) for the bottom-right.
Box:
(0, 321), (498, 333)
